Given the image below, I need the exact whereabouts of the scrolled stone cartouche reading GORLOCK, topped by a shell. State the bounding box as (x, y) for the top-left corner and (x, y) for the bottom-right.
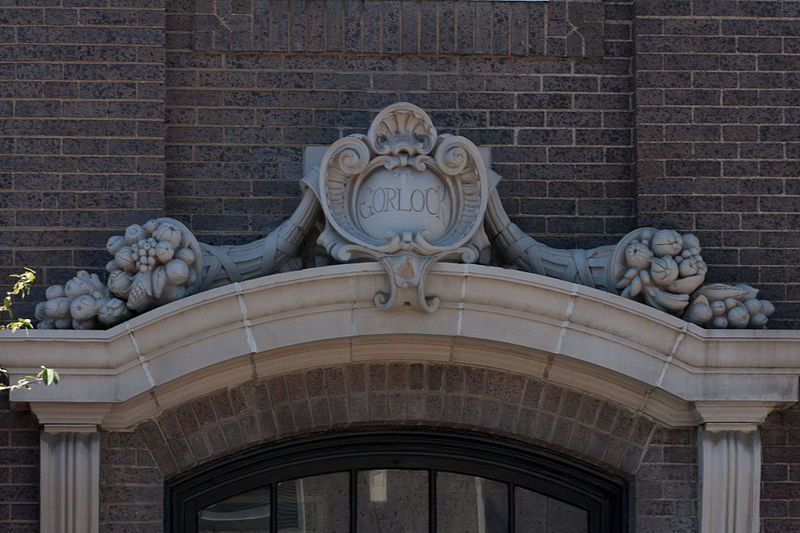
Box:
(310, 103), (488, 311)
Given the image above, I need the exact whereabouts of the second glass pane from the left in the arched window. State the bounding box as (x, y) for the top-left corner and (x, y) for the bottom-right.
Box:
(277, 472), (350, 533)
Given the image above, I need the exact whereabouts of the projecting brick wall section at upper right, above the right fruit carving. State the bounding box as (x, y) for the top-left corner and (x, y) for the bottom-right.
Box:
(636, 0), (800, 328)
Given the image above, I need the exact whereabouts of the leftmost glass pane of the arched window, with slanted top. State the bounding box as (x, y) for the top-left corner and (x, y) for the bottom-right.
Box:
(197, 487), (269, 533)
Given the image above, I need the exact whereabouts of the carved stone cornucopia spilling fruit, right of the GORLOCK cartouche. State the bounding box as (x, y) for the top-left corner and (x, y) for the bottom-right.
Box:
(486, 192), (775, 328)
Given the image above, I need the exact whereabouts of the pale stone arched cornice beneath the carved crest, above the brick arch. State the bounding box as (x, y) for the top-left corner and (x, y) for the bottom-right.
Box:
(0, 263), (800, 428)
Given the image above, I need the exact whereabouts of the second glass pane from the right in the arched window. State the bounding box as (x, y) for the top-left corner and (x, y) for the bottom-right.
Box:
(436, 472), (508, 533)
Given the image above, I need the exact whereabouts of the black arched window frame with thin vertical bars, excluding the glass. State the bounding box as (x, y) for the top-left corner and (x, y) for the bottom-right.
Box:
(164, 427), (629, 533)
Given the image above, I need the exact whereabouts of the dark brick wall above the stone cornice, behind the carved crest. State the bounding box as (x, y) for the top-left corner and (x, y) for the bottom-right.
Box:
(0, 0), (800, 327)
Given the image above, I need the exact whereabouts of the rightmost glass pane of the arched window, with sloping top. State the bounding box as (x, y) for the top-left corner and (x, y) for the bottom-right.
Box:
(514, 487), (589, 533)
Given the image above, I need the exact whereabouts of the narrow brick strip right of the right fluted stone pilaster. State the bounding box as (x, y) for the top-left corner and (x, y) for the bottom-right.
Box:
(761, 405), (800, 533)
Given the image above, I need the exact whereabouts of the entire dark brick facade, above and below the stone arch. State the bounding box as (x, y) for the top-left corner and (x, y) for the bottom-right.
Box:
(0, 0), (800, 532)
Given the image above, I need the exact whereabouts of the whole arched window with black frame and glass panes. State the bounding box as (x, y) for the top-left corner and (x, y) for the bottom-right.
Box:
(166, 428), (627, 533)
